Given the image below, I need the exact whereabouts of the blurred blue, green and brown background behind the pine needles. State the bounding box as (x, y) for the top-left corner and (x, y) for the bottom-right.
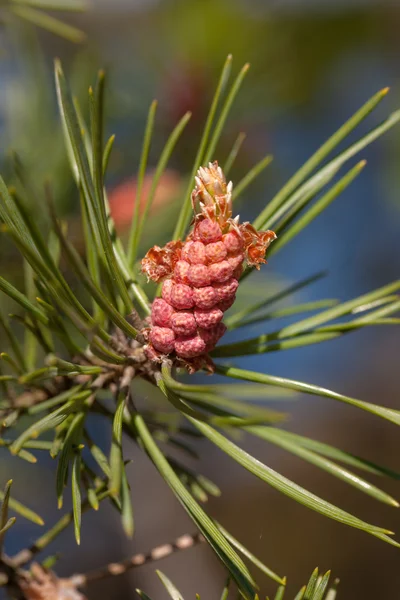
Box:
(0, 0), (400, 600)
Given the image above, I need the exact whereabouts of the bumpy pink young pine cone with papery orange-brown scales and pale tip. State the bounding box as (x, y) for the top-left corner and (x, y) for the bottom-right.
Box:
(142, 162), (276, 372)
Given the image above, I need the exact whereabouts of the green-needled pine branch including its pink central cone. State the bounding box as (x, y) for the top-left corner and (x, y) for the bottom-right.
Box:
(0, 54), (400, 600)
